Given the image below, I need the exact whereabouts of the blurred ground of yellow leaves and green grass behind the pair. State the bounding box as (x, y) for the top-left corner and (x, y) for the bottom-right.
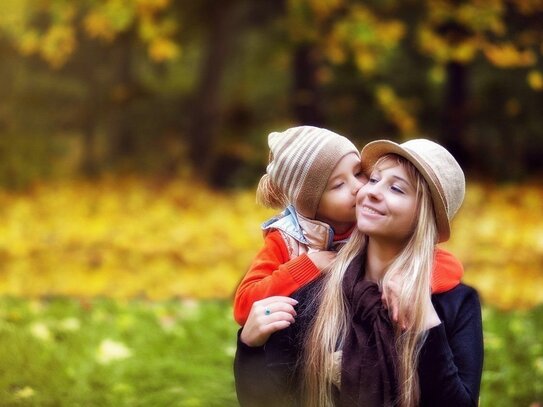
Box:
(0, 179), (543, 407)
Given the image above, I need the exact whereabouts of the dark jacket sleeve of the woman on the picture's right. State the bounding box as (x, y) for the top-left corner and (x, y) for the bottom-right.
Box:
(419, 287), (483, 407)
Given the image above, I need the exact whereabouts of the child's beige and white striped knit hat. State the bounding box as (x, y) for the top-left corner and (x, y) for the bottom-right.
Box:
(257, 126), (359, 219)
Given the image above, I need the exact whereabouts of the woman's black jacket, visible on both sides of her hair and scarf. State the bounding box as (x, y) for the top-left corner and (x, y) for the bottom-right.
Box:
(234, 280), (483, 407)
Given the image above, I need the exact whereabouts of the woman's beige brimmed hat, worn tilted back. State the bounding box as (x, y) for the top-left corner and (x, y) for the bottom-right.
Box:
(362, 139), (466, 242)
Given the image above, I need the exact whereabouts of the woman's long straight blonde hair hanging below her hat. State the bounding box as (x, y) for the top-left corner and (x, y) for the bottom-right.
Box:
(302, 155), (438, 407)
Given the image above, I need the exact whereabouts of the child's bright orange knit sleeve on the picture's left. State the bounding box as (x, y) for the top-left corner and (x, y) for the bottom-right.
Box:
(234, 230), (320, 325)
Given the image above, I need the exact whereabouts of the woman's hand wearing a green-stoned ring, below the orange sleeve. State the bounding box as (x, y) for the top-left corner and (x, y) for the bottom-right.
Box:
(240, 296), (298, 347)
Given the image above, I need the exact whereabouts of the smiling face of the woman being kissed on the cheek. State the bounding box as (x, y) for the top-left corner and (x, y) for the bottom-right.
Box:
(356, 159), (418, 243)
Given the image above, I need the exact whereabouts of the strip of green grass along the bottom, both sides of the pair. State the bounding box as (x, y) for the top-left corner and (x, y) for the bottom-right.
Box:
(0, 298), (543, 407)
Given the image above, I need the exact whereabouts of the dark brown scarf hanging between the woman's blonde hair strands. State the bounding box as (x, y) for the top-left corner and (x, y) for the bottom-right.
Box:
(339, 255), (398, 407)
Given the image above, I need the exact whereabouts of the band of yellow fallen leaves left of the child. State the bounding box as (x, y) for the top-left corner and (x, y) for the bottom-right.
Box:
(0, 180), (269, 298)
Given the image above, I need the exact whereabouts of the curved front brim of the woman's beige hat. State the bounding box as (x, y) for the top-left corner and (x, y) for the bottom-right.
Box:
(360, 140), (451, 242)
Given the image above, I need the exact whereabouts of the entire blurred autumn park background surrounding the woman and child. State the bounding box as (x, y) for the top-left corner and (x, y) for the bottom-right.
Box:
(0, 0), (543, 406)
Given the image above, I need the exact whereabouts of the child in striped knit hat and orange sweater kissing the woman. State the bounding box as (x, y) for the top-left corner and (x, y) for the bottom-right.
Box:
(234, 126), (463, 325)
